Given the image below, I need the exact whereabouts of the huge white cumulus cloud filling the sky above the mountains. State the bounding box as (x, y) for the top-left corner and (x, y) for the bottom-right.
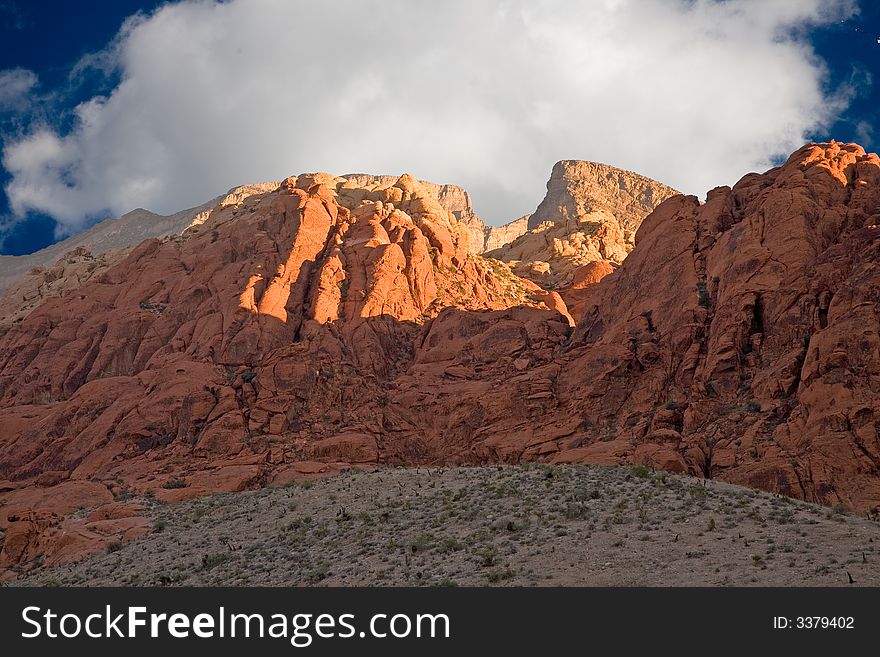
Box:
(3, 0), (855, 232)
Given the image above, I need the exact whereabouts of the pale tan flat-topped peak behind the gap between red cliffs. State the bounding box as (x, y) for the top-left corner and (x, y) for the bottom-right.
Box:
(486, 160), (678, 288)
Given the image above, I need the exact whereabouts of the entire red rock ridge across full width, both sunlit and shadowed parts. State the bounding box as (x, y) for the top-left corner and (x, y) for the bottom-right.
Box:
(0, 142), (880, 573)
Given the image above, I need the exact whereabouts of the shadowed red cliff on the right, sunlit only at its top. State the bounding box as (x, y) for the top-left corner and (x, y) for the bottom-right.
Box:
(554, 142), (880, 510)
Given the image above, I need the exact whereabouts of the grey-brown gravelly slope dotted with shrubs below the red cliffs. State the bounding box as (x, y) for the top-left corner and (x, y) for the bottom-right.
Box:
(13, 465), (880, 586)
